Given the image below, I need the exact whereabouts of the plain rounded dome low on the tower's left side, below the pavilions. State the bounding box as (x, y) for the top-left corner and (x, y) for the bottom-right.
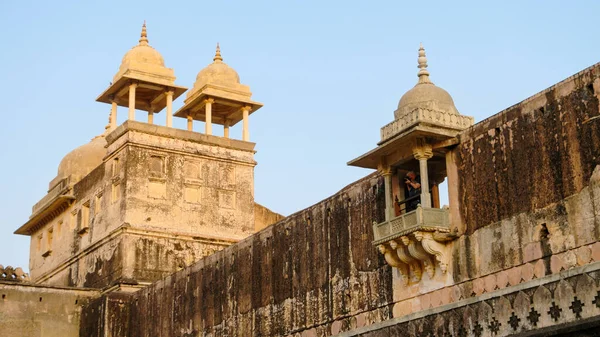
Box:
(57, 135), (106, 183)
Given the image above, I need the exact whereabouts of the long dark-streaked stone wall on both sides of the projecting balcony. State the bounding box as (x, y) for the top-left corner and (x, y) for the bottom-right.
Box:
(84, 65), (600, 337)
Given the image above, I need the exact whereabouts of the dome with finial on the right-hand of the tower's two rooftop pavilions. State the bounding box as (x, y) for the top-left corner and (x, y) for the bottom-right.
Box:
(187, 43), (240, 97)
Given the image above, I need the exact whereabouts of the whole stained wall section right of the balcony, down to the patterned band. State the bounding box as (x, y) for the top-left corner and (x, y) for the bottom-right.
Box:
(450, 61), (600, 284)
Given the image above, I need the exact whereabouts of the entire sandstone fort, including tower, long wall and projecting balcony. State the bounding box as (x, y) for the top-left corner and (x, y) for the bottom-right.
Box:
(0, 24), (600, 337)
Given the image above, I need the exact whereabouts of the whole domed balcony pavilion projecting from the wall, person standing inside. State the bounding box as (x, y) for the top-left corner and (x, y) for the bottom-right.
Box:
(348, 45), (473, 284)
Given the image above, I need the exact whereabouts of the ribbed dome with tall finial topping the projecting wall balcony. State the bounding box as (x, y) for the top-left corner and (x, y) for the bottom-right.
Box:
(394, 44), (459, 119)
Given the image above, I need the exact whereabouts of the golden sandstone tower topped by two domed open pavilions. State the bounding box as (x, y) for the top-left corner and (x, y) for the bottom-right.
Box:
(15, 23), (262, 290)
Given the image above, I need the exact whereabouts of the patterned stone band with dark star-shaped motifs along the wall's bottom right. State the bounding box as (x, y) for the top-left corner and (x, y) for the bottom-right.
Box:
(340, 264), (600, 337)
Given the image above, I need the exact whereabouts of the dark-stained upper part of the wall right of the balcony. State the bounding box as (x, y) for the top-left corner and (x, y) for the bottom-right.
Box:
(459, 65), (600, 233)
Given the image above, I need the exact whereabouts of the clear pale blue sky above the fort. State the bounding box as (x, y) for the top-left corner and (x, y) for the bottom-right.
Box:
(0, 1), (600, 267)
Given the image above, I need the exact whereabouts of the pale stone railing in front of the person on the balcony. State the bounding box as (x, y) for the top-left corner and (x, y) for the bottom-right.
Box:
(373, 205), (450, 245)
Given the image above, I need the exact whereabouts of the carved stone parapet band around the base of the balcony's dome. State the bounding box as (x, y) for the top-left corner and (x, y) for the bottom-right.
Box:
(381, 108), (474, 142)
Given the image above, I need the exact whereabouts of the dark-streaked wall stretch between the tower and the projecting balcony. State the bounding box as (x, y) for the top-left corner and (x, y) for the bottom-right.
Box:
(89, 175), (392, 336)
